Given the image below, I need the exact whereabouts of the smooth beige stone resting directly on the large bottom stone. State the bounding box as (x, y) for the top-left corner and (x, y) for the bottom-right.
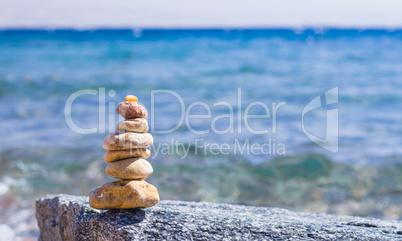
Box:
(106, 158), (154, 180)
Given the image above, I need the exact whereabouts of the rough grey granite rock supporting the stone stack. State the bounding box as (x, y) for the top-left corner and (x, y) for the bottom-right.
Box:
(36, 195), (402, 241)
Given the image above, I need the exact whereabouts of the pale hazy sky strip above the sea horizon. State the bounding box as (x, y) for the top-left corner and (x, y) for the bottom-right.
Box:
(0, 0), (402, 28)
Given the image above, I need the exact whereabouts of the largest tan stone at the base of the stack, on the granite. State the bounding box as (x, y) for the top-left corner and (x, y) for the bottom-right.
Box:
(89, 180), (159, 209)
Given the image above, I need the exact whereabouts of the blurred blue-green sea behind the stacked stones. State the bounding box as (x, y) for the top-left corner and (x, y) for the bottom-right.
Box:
(0, 29), (402, 238)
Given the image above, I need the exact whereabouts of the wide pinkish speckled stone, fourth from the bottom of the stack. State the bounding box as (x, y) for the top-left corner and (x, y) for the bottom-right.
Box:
(103, 132), (154, 151)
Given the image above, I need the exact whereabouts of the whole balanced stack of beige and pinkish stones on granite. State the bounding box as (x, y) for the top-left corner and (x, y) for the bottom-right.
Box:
(89, 95), (159, 209)
